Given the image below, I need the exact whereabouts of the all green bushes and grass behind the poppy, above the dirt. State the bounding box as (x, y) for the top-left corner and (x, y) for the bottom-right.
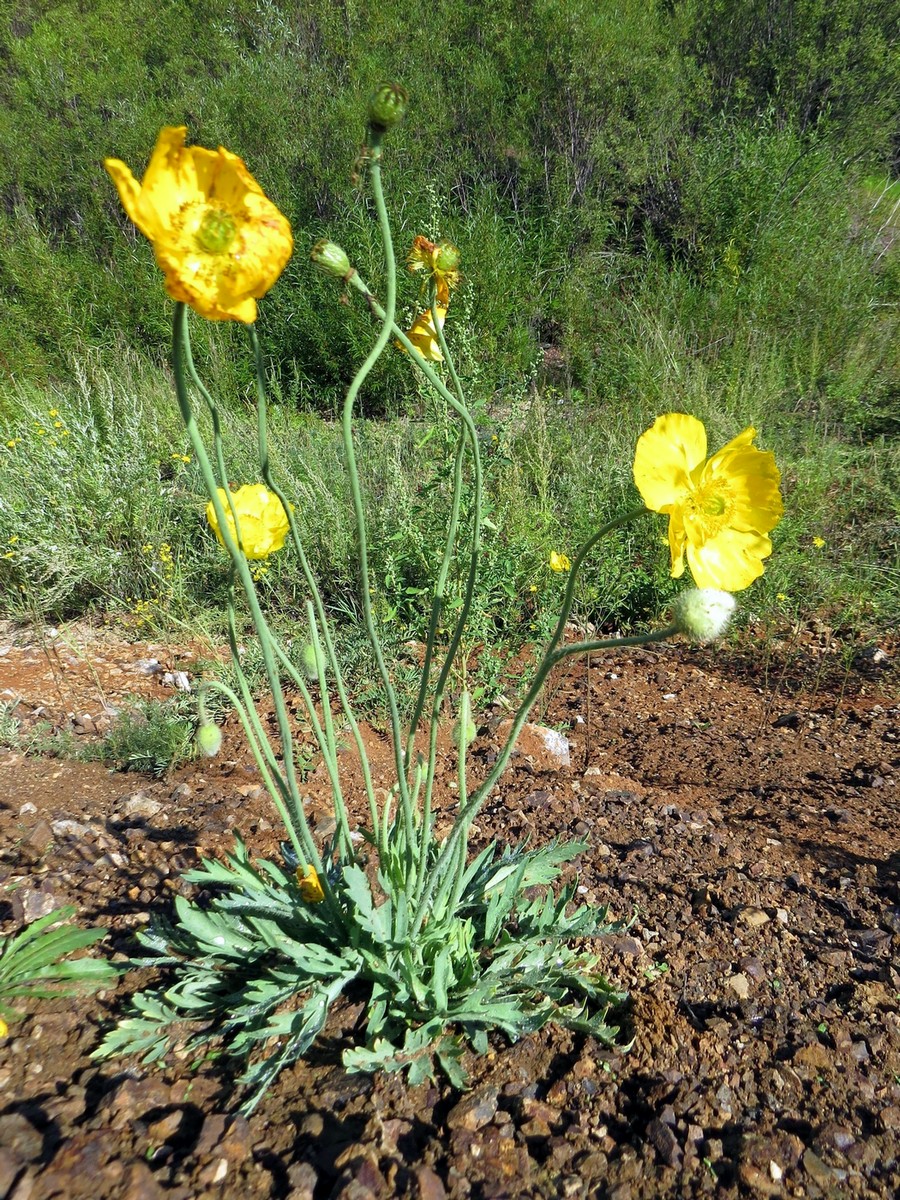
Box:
(0, 0), (900, 642)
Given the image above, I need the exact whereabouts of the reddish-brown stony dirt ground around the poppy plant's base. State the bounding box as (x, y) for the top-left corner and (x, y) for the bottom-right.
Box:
(0, 629), (900, 1200)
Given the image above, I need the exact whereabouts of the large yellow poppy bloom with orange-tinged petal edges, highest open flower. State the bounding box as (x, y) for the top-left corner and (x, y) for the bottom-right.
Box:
(104, 126), (293, 323)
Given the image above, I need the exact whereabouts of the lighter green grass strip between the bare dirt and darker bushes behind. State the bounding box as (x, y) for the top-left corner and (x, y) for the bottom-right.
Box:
(0, 336), (900, 646)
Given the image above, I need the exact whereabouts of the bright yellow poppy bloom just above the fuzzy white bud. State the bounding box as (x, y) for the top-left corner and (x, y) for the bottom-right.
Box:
(634, 413), (784, 592)
